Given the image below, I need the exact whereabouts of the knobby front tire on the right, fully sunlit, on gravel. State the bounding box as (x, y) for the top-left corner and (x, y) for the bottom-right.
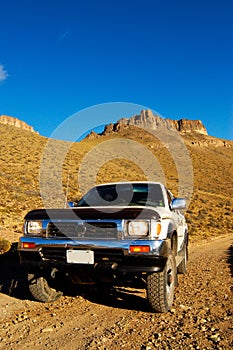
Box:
(147, 252), (177, 312)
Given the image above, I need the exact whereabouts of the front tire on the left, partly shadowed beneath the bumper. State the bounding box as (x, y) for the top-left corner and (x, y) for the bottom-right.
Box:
(28, 274), (63, 303)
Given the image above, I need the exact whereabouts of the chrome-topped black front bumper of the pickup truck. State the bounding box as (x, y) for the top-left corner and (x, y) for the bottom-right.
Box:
(18, 236), (170, 272)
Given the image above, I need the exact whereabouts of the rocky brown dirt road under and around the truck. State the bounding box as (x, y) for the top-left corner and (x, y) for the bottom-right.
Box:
(0, 235), (233, 350)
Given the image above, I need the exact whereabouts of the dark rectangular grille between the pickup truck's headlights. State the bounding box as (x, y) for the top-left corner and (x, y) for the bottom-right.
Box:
(46, 221), (118, 239)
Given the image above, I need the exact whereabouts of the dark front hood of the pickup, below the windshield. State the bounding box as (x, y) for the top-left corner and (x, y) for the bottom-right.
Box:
(25, 206), (160, 221)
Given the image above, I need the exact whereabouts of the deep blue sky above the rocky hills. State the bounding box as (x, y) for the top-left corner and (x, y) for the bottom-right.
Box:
(0, 0), (233, 139)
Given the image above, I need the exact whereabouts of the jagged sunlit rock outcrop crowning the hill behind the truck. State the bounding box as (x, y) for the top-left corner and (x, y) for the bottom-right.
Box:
(117, 109), (208, 135)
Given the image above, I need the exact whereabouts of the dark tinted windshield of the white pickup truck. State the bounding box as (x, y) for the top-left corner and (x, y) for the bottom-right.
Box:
(77, 183), (164, 207)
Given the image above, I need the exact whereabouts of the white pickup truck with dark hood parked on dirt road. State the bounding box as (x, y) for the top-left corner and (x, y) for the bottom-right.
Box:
(18, 182), (188, 312)
